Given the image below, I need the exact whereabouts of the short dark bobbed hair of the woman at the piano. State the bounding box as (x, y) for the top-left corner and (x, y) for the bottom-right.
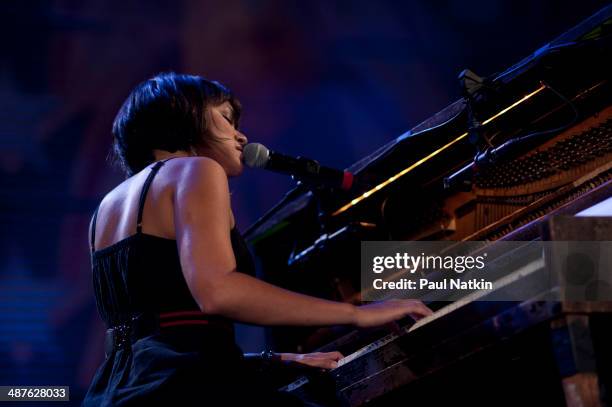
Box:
(112, 72), (241, 177)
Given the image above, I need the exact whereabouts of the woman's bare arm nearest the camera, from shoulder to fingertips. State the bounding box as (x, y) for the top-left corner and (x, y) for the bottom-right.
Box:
(174, 158), (430, 326)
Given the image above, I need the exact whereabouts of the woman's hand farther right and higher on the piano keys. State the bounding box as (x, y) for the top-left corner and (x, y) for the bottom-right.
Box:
(355, 299), (433, 328)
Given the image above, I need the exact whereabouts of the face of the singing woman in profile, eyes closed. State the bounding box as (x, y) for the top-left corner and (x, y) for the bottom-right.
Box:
(202, 102), (247, 177)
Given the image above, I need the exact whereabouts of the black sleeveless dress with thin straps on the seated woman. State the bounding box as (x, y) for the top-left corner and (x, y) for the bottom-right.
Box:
(83, 161), (316, 406)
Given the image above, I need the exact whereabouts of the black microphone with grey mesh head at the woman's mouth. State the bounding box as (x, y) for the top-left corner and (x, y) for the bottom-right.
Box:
(242, 143), (354, 191)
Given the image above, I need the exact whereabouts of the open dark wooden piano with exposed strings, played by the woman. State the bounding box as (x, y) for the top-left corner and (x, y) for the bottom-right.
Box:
(245, 6), (612, 406)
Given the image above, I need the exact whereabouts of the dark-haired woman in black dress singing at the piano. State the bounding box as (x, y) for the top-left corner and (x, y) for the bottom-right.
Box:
(83, 73), (431, 406)
